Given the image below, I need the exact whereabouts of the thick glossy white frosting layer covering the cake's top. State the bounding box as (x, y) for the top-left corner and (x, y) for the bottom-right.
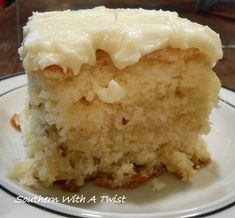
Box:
(19, 7), (222, 74)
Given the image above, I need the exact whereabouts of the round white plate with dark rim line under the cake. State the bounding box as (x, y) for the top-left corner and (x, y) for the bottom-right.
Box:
(0, 75), (235, 217)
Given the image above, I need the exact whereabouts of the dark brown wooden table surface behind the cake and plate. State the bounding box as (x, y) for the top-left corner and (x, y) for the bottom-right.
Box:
(0, 0), (235, 89)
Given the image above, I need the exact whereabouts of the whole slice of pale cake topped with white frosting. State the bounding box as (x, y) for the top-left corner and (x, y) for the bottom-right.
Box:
(10, 7), (222, 188)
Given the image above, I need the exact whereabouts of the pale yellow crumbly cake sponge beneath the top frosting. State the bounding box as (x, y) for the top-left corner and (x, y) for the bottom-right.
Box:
(10, 48), (220, 188)
